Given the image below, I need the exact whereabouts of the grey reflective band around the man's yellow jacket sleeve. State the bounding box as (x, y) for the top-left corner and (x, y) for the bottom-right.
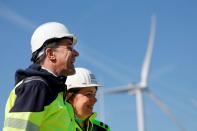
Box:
(4, 118), (39, 131)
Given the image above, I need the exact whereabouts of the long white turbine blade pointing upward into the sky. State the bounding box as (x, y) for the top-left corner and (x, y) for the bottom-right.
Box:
(140, 15), (156, 87)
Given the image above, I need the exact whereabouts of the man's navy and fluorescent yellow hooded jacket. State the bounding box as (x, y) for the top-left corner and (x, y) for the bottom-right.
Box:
(3, 64), (75, 131)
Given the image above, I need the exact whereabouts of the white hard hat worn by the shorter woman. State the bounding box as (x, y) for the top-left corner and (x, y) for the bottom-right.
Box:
(66, 68), (101, 90)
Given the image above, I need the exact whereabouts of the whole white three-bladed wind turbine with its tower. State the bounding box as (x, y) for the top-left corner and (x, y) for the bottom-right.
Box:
(105, 15), (185, 131)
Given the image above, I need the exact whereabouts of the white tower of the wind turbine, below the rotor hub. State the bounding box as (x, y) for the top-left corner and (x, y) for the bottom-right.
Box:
(135, 88), (144, 131)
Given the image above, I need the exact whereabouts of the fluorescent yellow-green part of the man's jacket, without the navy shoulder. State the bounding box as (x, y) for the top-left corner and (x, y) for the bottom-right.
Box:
(3, 77), (75, 131)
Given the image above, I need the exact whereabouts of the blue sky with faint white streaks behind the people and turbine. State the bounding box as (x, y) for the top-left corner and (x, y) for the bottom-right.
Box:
(0, 0), (197, 131)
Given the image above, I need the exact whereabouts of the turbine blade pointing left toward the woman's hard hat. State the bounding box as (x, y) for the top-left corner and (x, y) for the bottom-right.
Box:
(105, 85), (136, 94)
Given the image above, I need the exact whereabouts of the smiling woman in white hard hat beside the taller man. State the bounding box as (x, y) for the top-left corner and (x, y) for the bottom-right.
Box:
(66, 68), (110, 131)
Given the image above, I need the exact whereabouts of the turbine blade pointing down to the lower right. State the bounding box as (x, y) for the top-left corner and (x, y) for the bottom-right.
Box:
(145, 90), (186, 131)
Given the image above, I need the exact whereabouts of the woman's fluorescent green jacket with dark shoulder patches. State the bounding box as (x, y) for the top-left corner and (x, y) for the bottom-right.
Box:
(75, 113), (110, 131)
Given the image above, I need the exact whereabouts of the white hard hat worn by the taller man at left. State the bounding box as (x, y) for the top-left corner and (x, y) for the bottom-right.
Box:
(31, 22), (77, 53)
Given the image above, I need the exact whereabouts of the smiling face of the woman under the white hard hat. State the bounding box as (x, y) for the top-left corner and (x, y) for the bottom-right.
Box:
(70, 87), (97, 119)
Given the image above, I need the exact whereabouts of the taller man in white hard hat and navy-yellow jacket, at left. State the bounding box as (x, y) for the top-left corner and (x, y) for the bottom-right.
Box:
(3, 22), (79, 131)
